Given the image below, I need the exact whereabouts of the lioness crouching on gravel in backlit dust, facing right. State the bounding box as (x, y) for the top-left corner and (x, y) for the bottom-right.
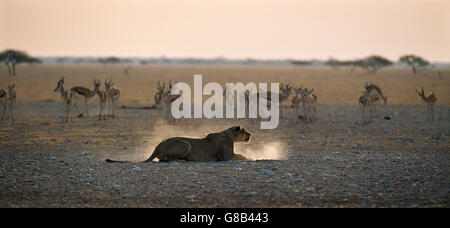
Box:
(106, 126), (250, 162)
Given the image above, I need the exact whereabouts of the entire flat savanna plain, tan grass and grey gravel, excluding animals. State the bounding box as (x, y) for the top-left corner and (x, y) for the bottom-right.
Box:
(0, 65), (450, 207)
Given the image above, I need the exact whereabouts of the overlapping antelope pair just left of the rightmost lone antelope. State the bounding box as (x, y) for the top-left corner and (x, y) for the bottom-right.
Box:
(358, 82), (387, 123)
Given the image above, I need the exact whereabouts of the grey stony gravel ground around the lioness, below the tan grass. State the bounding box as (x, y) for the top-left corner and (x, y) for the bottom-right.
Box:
(0, 102), (450, 207)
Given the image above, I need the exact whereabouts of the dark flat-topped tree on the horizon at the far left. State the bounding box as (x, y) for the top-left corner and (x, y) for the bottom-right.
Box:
(0, 49), (42, 76)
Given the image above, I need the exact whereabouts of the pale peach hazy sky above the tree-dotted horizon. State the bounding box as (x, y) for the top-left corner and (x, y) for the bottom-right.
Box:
(0, 0), (450, 62)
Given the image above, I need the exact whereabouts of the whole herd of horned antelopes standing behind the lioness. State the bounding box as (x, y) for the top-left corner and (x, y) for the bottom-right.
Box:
(0, 77), (437, 124)
